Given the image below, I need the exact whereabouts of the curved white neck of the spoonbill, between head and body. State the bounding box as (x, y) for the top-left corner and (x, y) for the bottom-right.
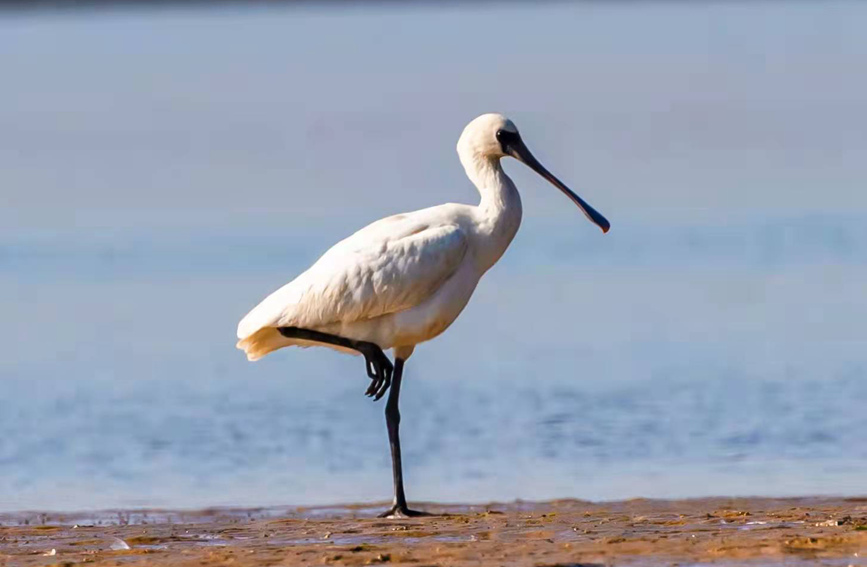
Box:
(461, 156), (522, 271)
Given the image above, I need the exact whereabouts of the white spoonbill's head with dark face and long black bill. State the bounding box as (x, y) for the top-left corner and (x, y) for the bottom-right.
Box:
(458, 113), (611, 232)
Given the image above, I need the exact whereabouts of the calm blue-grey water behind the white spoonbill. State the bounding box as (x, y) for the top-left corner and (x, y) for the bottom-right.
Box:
(0, 3), (867, 511)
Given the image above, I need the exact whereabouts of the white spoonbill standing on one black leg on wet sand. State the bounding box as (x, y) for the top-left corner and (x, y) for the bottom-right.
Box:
(237, 113), (611, 518)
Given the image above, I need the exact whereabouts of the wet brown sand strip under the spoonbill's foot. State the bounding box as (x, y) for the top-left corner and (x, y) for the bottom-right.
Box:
(0, 498), (867, 567)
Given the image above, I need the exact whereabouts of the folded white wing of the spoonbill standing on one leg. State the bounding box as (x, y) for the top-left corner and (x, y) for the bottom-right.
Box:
(238, 220), (468, 339)
